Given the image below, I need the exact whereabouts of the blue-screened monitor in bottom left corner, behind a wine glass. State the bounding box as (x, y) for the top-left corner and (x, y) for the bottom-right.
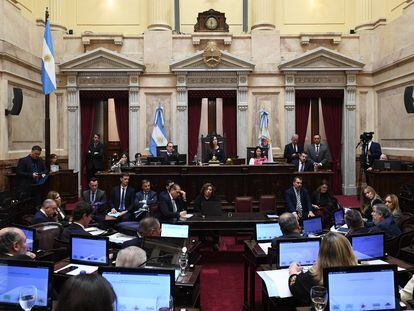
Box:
(0, 259), (53, 310)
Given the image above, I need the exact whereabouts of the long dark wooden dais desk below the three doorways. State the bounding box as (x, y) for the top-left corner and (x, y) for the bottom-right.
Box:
(96, 164), (333, 204)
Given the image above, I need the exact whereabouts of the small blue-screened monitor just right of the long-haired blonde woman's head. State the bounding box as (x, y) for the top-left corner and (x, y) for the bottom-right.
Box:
(350, 233), (385, 260)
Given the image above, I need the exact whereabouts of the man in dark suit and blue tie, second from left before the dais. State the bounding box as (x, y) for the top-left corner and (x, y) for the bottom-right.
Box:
(108, 173), (135, 220)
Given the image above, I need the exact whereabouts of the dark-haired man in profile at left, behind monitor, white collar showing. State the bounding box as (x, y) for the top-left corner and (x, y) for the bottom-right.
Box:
(60, 202), (93, 243)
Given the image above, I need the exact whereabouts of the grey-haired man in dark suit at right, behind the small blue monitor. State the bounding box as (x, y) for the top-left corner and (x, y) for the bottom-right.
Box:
(369, 204), (401, 240)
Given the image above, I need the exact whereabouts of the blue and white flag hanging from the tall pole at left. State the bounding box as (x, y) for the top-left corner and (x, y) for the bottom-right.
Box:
(42, 20), (56, 94)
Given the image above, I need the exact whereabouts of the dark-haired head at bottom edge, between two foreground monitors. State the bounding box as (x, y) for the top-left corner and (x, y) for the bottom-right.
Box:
(53, 273), (117, 311)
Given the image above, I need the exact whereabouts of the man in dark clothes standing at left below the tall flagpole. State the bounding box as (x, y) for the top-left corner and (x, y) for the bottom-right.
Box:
(16, 146), (47, 204)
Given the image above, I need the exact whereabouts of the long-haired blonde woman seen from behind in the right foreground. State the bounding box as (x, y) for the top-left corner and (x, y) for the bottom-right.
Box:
(288, 232), (358, 306)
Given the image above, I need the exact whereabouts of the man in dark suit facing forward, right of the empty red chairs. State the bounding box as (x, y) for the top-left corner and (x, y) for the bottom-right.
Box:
(285, 176), (313, 219)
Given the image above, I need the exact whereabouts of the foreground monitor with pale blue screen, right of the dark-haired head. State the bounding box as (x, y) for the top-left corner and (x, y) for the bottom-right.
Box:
(98, 267), (175, 310)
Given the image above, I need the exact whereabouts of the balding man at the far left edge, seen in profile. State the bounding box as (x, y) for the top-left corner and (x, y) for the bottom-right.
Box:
(0, 227), (36, 260)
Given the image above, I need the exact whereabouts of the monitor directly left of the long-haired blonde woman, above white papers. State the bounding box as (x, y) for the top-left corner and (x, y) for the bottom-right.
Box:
(276, 238), (321, 268)
